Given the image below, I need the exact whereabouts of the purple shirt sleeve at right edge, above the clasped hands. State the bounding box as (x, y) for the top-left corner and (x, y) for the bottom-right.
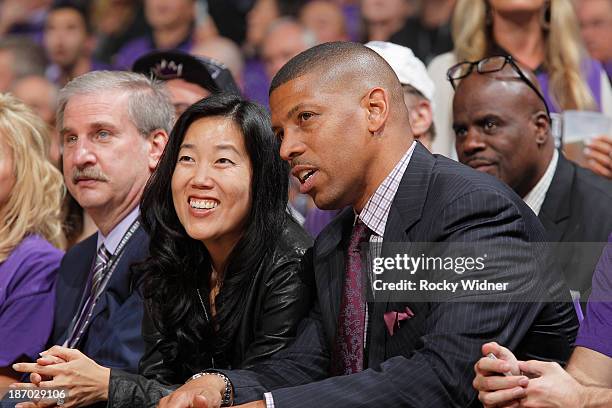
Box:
(576, 234), (612, 357)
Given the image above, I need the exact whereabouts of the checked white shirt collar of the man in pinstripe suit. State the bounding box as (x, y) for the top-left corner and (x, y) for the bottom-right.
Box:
(359, 141), (417, 237)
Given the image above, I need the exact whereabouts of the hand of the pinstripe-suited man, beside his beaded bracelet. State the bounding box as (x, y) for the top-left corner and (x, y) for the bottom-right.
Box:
(158, 375), (225, 408)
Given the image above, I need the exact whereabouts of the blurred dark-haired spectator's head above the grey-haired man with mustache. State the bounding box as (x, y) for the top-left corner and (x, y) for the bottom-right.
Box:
(43, 1), (110, 87)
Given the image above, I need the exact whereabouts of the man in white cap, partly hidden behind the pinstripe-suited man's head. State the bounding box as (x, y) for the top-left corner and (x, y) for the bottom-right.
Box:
(365, 41), (436, 150)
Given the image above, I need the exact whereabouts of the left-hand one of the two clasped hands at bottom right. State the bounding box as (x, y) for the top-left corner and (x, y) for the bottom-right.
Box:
(473, 343), (529, 408)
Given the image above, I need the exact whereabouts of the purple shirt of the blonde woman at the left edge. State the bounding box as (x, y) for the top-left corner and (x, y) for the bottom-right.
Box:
(0, 235), (64, 367)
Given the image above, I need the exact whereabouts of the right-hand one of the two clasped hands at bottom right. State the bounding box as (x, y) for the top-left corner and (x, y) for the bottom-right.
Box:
(519, 361), (585, 408)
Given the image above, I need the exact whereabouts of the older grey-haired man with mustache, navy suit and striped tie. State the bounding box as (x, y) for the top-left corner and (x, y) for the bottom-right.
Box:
(15, 71), (174, 399)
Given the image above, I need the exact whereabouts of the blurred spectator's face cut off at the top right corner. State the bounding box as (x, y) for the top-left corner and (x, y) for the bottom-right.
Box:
(576, 0), (612, 79)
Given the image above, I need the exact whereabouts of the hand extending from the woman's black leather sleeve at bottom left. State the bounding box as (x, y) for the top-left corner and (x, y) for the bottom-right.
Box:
(13, 346), (110, 408)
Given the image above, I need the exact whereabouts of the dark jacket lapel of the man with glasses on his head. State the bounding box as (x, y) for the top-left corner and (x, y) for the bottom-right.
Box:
(538, 153), (576, 242)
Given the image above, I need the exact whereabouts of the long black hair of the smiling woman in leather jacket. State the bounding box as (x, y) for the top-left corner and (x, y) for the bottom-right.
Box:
(137, 94), (289, 381)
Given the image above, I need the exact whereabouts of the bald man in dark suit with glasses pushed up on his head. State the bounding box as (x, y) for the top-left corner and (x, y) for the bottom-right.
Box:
(453, 57), (612, 313)
